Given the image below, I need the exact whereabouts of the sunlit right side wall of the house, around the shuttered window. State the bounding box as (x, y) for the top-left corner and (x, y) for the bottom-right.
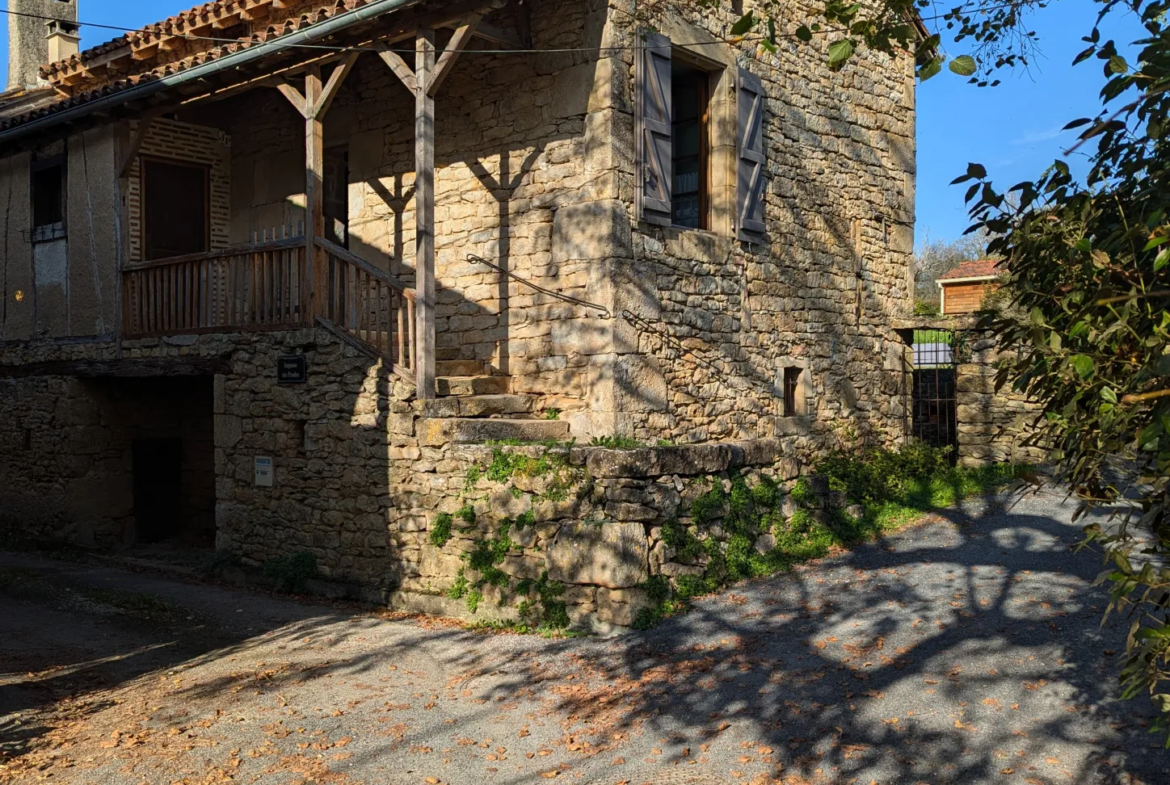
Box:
(589, 2), (915, 446)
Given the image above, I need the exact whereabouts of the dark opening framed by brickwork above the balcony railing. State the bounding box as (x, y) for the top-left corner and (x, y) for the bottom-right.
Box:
(143, 160), (208, 261)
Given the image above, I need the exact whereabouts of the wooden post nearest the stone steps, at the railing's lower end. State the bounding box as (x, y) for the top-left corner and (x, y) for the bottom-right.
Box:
(414, 28), (435, 400)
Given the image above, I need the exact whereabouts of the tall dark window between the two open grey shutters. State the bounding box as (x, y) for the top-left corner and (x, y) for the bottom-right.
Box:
(670, 61), (710, 229)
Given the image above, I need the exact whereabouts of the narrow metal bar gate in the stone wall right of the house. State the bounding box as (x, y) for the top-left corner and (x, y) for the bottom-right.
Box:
(910, 330), (958, 456)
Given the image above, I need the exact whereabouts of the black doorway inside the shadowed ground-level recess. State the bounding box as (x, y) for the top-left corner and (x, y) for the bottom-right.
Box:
(133, 439), (183, 543)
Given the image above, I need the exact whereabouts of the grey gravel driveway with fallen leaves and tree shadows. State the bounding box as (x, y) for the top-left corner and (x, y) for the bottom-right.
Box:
(0, 494), (1170, 785)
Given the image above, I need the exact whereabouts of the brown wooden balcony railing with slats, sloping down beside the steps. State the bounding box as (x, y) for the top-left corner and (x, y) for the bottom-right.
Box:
(122, 237), (418, 381)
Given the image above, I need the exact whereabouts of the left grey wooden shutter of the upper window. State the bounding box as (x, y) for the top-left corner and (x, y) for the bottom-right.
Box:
(635, 33), (674, 226)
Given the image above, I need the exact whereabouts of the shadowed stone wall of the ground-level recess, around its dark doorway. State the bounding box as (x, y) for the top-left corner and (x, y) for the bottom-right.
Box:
(0, 377), (215, 548)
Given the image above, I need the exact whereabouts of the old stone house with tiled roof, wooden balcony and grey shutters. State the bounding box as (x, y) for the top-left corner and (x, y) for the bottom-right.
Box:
(0, 0), (931, 627)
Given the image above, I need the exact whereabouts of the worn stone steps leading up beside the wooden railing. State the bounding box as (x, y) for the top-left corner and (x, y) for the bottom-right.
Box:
(421, 360), (569, 445)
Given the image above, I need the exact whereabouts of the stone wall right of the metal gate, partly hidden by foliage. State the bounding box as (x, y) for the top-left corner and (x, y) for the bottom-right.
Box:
(955, 330), (1047, 466)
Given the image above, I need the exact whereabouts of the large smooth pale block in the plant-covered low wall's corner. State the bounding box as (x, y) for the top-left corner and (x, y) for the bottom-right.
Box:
(546, 523), (649, 588)
